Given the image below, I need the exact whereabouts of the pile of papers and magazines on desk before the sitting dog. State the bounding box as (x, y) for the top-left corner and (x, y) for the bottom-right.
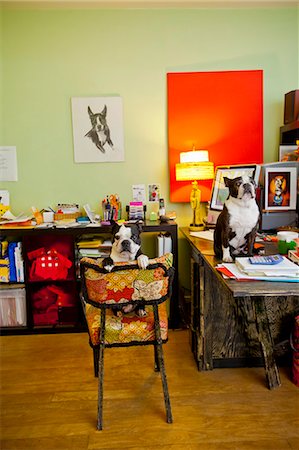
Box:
(217, 256), (299, 282)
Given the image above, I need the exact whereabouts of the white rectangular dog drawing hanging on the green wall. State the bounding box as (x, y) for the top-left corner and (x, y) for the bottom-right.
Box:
(71, 96), (125, 163)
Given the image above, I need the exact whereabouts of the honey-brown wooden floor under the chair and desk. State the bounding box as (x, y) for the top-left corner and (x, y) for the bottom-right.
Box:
(0, 330), (299, 450)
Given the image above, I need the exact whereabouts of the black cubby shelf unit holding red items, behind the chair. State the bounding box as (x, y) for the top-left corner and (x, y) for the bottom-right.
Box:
(0, 221), (180, 334)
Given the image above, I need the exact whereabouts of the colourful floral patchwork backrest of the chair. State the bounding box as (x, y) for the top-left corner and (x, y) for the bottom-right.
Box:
(80, 253), (174, 308)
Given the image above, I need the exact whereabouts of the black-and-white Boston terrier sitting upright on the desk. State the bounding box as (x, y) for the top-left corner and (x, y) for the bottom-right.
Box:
(214, 175), (260, 262)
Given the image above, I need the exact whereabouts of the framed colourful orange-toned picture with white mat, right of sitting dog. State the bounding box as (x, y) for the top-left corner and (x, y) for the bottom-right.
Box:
(265, 167), (297, 211)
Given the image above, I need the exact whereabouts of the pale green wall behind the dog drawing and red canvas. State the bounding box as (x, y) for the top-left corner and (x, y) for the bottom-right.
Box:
(0, 7), (298, 220)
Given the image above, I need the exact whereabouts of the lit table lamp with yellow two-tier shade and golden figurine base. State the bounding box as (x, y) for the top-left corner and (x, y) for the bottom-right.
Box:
(175, 147), (214, 231)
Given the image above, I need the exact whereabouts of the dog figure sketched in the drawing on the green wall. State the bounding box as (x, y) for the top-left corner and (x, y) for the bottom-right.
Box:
(85, 105), (113, 153)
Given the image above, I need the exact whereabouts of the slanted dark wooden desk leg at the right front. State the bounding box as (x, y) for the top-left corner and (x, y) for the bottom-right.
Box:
(254, 297), (281, 389)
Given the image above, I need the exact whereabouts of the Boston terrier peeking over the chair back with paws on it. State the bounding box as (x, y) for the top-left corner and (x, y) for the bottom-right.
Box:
(102, 222), (149, 317)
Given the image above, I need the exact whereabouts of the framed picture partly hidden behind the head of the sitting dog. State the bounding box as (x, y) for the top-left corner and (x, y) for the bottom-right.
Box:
(210, 164), (261, 211)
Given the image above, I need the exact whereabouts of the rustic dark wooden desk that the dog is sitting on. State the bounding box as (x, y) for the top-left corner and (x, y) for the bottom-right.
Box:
(181, 228), (299, 389)
